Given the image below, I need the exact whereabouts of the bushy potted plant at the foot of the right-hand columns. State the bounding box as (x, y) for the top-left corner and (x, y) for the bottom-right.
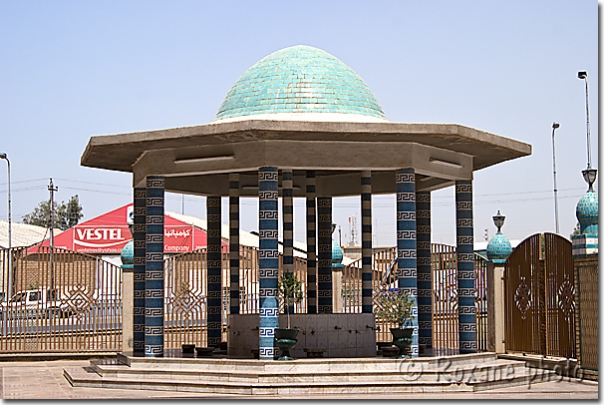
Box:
(375, 288), (415, 358)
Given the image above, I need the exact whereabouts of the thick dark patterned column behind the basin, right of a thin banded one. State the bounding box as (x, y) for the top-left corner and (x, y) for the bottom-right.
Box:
(317, 197), (333, 314)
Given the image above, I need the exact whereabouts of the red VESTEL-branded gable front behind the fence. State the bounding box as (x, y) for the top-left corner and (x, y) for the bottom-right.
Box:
(28, 204), (228, 254)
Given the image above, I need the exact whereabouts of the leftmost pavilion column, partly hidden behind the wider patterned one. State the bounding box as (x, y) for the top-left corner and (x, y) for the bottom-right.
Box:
(132, 187), (147, 357)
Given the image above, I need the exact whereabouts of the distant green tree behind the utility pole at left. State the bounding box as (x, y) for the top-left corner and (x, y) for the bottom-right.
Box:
(22, 194), (84, 231)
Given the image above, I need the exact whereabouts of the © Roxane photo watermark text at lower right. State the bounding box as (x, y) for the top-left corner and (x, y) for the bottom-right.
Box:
(398, 357), (584, 389)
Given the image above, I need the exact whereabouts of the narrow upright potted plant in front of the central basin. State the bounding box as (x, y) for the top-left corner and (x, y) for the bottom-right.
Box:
(275, 272), (302, 360)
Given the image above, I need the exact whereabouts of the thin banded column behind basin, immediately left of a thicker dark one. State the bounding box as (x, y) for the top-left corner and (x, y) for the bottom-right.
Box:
(306, 170), (317, 314)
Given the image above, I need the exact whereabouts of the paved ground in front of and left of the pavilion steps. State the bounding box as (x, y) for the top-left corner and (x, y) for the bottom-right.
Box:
(0, 360), (598, 401)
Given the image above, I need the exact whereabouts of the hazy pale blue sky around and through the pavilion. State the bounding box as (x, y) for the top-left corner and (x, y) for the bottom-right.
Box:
(0, 0), (599, 245)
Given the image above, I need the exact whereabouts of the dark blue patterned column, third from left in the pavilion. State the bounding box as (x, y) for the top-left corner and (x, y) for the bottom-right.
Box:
(206, 196), (222, 347)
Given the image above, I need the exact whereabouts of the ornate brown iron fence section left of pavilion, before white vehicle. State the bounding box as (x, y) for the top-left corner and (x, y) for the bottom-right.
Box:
(0, 247), (122, 353)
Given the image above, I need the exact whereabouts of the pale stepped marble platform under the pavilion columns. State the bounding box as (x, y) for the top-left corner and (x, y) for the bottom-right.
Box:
(64, 353), (553, 395)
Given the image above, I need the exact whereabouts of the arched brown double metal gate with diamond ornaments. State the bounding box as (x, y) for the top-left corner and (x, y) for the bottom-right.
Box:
(504, 233), (576, 358)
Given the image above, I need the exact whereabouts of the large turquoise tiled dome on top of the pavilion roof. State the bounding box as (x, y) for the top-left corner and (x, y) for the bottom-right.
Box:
(215, 45), (386, 121)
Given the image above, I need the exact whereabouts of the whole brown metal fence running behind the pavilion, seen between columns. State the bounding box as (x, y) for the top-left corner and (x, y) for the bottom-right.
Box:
(0, 240), (486, 355)
